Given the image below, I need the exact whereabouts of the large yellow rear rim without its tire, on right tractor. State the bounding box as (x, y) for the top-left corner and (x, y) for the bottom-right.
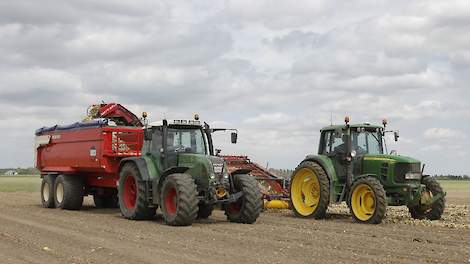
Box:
(291, 168), (320, 216)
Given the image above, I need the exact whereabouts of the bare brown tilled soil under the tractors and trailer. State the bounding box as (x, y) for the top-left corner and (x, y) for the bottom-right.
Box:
(0, 193), (470, 264)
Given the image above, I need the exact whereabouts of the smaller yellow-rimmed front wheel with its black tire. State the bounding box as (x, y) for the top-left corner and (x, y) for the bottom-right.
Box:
(349, 177), (387, 224)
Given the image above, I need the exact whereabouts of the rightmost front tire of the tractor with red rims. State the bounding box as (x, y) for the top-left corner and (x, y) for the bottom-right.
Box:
(224, 174), (263, 224)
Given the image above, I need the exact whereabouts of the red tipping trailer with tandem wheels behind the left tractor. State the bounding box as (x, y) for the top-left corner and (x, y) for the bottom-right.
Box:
(36, 104), (143, 209)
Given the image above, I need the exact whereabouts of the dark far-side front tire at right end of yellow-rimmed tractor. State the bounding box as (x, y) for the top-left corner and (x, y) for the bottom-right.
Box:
(408, 176), (445, 220)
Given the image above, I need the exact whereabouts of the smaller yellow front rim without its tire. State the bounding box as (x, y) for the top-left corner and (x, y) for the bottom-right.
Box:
(351, 184), (375, 221)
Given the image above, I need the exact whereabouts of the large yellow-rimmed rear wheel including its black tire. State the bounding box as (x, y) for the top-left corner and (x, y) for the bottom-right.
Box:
(290, 161), (330, 219)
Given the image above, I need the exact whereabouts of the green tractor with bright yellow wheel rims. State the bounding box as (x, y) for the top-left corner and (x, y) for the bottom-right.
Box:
(290, 117), (445, 224)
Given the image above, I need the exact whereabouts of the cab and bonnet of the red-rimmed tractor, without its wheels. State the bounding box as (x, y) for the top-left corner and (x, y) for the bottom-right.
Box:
(142, 119), (229, 196)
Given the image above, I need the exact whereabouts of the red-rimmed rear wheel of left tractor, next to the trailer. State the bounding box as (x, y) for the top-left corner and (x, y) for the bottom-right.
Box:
(118, 163), (156, 220)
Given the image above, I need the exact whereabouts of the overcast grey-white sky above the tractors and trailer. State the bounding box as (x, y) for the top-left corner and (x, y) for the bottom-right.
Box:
(0, 0), (470, 174)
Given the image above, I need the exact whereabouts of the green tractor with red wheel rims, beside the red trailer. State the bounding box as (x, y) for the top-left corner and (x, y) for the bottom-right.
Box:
(118, 116), (263, 226)
